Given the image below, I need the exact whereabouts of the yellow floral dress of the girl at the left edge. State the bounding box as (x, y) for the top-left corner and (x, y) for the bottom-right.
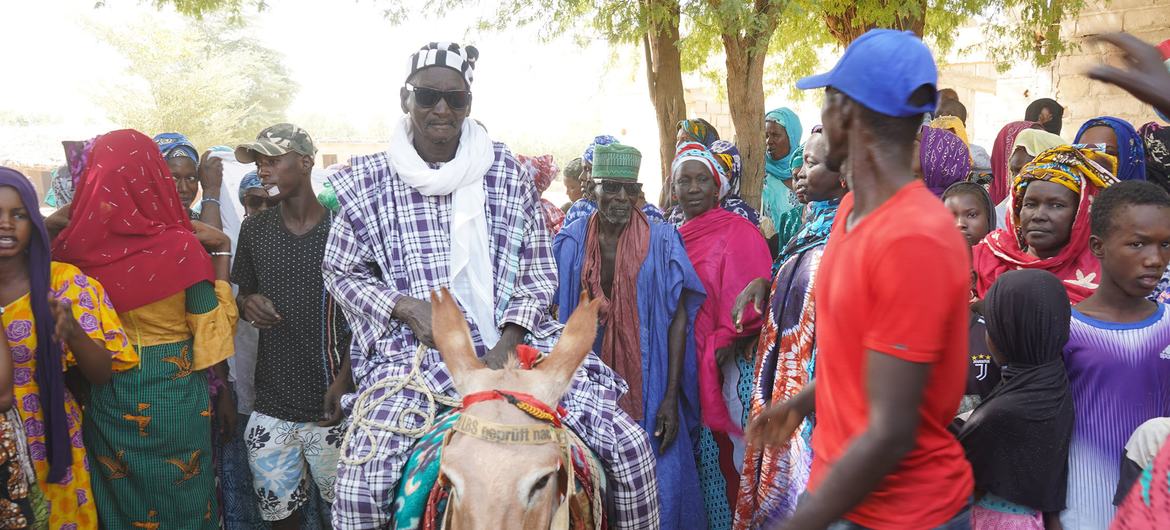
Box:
(4, 262), (138, 530)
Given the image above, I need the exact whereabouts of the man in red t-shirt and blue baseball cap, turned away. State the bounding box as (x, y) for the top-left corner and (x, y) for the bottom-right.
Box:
(750, 29), (972, 530)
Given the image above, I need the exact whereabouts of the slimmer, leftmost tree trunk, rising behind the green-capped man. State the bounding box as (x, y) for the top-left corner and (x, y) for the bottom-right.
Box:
(642, 0), (687, 207)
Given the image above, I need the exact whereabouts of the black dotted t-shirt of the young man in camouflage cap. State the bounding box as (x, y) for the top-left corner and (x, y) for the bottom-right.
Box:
(232, 206), (349, 422)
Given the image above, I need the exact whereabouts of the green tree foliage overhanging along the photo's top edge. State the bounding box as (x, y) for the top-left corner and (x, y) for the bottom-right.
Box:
(143, 0), (1085, 87)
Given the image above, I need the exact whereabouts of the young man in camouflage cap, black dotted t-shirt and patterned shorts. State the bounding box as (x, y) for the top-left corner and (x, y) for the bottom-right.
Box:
(232, 123), (352, 529)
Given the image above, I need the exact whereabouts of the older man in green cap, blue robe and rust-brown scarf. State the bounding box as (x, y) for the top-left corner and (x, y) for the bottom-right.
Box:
(552, 144), (707, 529)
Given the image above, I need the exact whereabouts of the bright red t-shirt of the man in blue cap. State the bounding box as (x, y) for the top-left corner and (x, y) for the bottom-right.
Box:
(808, 181), (973, 530)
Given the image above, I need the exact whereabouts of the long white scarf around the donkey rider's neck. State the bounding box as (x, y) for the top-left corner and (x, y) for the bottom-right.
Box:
(390, 116), (500, 349)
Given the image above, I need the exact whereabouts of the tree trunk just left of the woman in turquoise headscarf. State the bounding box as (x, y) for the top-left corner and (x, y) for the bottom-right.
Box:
(723, 35), (772, 209)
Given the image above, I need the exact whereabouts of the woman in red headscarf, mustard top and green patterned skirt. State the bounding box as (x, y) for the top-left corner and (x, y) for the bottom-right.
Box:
(53, 130), (236, 529)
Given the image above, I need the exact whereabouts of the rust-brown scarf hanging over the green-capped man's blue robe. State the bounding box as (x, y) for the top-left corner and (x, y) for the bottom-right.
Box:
(581, 208), (651, 421)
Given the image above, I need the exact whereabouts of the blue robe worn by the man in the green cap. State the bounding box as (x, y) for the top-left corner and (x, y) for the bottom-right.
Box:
(552, 218), (707, 529)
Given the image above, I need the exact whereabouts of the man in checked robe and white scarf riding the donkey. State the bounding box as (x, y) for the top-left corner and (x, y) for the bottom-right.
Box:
(323, 42), (659, 529)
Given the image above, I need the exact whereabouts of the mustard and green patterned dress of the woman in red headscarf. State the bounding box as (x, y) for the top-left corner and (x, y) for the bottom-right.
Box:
(85, 281), (236, 530)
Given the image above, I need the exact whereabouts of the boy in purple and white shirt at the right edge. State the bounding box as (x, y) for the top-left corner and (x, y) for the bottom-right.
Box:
(1060, 181), (1170, 530)
